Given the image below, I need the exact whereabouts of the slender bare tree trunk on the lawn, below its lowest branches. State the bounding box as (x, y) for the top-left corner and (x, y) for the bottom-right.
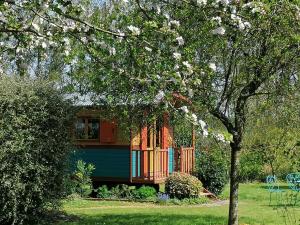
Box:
(228, 144), (239, 225)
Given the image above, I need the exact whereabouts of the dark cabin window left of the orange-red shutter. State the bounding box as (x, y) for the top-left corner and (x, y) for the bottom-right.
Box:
(75, 118), (99, 140)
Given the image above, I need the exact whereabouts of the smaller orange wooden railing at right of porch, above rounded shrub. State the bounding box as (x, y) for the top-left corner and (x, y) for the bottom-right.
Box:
(175, 147), (195, 173)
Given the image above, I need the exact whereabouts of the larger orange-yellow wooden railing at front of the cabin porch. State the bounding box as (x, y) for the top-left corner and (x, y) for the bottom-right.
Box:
(131, 149), (169, 181)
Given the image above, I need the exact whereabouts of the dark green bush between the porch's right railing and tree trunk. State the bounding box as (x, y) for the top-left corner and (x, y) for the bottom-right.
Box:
(196, 149), (228, 195)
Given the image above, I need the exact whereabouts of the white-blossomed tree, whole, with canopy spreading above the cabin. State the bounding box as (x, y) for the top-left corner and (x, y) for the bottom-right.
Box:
(0, 0), (300, 224)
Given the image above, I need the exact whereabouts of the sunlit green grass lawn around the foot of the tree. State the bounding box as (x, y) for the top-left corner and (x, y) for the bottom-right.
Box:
(58, 184), (300, 225)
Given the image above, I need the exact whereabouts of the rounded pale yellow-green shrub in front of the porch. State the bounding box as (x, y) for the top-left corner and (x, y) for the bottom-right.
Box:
(165, 173), (202, 199)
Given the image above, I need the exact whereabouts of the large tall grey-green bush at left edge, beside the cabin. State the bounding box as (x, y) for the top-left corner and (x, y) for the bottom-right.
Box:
(0, 77), (73, 224)
